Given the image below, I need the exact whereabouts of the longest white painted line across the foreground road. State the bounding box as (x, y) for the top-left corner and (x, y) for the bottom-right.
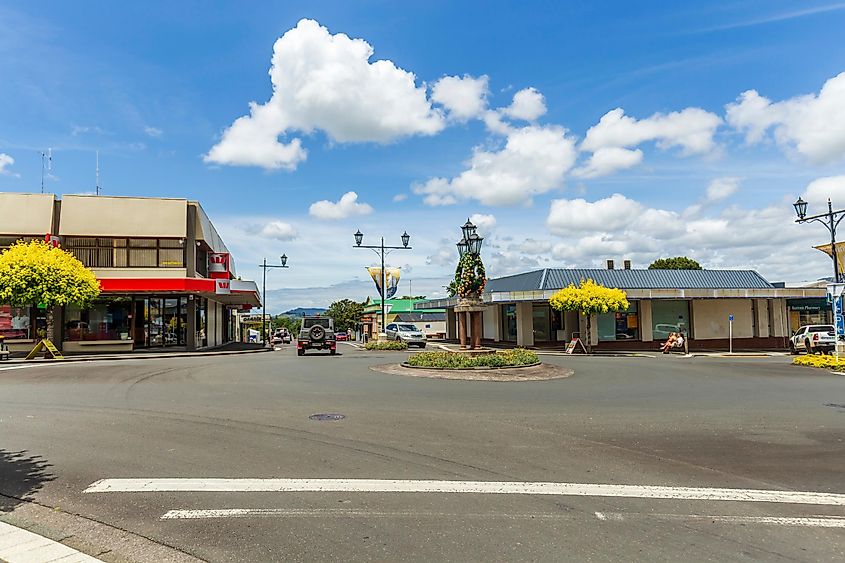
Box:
(83, 479), (845, 506)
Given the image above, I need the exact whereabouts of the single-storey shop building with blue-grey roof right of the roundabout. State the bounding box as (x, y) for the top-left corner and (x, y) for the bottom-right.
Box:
(416, 268), (826, 350)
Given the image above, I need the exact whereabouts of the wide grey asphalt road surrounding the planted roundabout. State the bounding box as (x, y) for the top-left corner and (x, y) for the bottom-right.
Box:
(0, 345), (845, 561)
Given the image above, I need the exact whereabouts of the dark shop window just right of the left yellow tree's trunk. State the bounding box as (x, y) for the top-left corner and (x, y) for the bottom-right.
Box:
(65, 298), (132, 341)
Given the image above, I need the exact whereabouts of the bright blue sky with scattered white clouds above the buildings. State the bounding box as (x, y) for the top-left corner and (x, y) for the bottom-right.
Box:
(0, 0), (845, 312)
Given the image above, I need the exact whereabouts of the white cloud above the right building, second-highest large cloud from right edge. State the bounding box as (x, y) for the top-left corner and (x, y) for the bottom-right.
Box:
(581, 108), (722, 155)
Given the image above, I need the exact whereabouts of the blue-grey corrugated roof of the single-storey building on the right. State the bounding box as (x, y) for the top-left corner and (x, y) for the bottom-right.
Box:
(486, 268), (774, 292)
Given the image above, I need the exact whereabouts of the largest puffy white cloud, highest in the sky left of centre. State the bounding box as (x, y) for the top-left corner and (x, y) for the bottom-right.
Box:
(204, 19), (445, 170)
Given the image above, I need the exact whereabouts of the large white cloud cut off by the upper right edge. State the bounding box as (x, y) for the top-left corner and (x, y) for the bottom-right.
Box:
(725, 72), (845, 164)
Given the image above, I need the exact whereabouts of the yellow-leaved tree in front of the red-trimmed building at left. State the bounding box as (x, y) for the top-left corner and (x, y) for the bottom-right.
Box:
(0, 240), (100, 340)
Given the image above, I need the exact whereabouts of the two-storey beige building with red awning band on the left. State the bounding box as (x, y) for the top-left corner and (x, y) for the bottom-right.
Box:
(0, 193), (261, 353)
